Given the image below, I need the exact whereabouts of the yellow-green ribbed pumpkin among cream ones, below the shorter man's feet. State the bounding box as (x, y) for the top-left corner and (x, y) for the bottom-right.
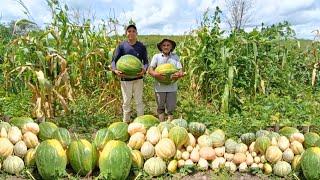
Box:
(169, 126), (189, 149)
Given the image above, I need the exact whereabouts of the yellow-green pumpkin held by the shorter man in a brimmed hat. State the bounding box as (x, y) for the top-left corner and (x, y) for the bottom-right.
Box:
(155, 63), (179, 85)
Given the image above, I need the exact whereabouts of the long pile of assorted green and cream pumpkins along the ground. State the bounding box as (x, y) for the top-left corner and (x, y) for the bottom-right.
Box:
(0, 115), (320, 179)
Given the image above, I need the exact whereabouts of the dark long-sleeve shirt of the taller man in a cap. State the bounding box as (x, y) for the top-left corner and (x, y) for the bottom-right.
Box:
(111, 41), (149, 81)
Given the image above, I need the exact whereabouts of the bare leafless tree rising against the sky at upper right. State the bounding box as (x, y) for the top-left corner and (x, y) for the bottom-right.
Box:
(226, 0), (254, 30)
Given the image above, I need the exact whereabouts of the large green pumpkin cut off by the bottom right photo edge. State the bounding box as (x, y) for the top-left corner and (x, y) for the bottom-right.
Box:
(300, 147), (320, 180)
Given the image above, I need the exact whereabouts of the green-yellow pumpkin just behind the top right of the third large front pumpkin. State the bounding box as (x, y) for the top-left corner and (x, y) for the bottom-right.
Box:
(108, 122), (129, 142)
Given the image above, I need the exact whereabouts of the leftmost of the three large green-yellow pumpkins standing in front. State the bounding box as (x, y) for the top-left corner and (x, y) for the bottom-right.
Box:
(36, 139), (67, 179)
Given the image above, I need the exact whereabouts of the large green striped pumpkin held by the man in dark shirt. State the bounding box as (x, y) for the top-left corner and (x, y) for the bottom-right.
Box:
(116, 54), (142, 78)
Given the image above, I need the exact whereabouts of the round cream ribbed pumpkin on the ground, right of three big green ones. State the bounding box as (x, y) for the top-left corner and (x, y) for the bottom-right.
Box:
(143, 157), (167, 176)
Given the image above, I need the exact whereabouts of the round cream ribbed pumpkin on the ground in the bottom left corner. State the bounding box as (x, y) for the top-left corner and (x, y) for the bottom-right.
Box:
(3, 156), (24, 174)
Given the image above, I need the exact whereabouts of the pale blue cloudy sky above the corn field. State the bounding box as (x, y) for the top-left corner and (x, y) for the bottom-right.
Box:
(0, 0), (320, 39)
